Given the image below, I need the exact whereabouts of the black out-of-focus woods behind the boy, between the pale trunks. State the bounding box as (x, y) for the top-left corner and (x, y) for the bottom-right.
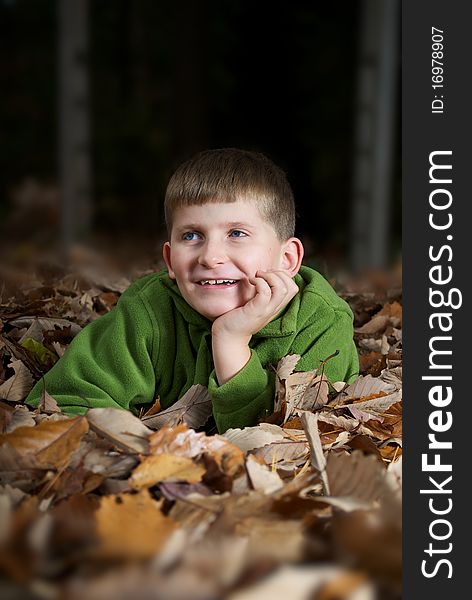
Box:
(0, 0), (401, 267)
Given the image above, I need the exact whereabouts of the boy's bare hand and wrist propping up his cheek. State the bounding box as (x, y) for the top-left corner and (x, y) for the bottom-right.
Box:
(212, 271), (298, 385)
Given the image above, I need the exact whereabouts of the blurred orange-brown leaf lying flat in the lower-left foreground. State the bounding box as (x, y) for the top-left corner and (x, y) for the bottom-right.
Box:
(95, 489), (177, 559)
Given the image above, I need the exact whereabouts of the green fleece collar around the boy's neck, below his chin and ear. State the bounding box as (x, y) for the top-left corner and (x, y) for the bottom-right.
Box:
(161, 272), (303, 339)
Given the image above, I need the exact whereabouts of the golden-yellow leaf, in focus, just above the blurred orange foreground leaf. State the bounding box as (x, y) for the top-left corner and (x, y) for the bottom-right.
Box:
(129, 454), (205, 489)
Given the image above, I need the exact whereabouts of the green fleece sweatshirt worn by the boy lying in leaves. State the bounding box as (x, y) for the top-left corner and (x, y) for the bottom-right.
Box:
(26, 267), (358, 432)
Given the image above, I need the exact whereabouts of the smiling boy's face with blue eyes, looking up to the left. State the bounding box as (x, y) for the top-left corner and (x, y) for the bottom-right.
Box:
(163, 200), (298, 320)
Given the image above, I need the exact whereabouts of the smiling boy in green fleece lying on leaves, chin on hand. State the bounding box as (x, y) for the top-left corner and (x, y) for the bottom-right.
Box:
(27, 148), (358, 432)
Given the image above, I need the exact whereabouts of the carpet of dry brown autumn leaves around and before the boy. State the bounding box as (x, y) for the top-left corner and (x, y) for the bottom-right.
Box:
(0, 258), (402, 600)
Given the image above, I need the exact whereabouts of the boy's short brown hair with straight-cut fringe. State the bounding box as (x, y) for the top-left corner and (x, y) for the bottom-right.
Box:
(164, 148), (295, 241)
